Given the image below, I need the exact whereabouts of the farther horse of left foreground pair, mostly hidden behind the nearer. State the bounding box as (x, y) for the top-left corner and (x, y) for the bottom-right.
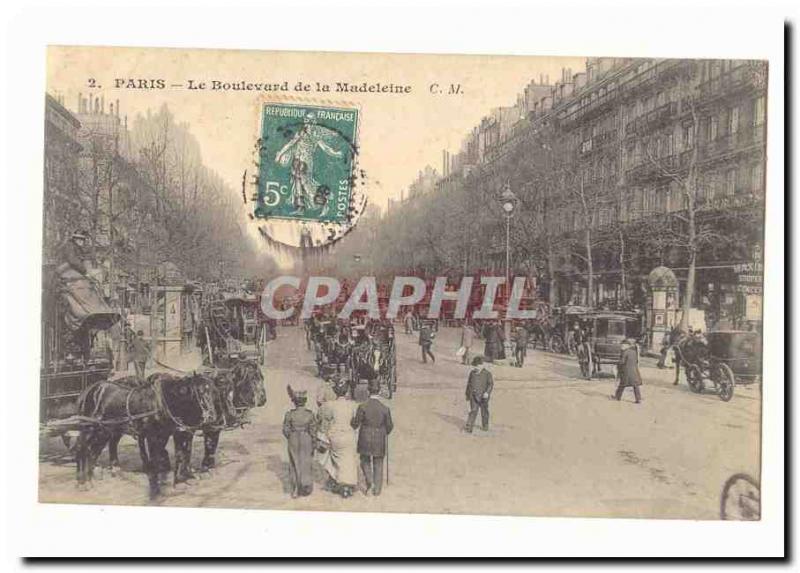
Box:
(184, 360), (267, 472)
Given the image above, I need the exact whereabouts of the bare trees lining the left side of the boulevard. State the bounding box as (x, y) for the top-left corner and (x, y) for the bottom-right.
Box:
(45, 105), (271, 286)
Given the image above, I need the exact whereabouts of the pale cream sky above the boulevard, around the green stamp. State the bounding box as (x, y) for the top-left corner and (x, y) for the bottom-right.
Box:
(47, 46), (585, 260)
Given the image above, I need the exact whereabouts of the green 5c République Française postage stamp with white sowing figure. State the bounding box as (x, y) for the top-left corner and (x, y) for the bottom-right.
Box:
(255, 103), (358, 223)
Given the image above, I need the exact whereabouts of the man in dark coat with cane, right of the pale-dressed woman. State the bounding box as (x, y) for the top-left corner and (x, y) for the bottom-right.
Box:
(352, 380), (394, 496)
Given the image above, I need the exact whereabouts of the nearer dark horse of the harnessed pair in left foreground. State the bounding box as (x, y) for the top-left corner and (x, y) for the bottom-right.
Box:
(76, 373), (217, 498)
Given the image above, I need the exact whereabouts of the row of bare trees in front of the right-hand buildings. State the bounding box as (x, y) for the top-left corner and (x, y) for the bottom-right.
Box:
(322, 59), (763, 326)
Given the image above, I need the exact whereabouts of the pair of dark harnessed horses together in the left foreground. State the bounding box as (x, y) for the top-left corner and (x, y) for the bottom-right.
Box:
(75, 360), (267, 497)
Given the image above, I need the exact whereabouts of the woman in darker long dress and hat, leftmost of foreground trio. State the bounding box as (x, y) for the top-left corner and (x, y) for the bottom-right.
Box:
(283, 386), (317, 497)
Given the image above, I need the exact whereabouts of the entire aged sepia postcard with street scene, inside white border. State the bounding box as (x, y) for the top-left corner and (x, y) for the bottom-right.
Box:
(39, 46), (768, 520)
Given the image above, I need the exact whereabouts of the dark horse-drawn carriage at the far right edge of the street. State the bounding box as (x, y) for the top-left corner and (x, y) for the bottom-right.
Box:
(675, 330), (761, 402)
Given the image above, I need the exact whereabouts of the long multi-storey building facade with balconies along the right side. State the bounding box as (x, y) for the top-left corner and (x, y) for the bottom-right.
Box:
(388, 58), (767, 328)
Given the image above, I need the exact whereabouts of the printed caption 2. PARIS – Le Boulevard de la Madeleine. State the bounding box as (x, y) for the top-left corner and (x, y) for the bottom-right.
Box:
(112, 78), (411, 94)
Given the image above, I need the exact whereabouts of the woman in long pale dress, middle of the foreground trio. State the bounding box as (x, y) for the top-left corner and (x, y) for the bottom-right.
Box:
(317, 379), (358, 498)
